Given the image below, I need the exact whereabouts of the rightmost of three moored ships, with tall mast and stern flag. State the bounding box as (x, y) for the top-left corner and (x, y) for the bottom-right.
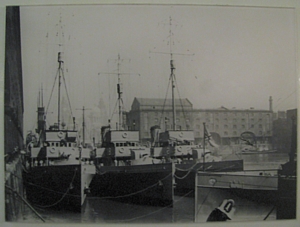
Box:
(151, 17), (244, 195)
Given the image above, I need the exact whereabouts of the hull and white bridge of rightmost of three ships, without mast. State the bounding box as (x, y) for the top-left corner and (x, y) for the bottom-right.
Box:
(151, 124), (244, 193)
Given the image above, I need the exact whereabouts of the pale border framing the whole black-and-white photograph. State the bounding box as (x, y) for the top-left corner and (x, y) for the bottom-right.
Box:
(0, 0), (300, 227)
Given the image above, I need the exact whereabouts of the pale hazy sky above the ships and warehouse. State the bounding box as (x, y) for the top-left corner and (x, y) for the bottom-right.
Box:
(20, 5), (297, 131)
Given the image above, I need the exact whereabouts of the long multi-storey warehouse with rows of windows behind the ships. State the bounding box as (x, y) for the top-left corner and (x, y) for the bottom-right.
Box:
(126, 97), (273, 150)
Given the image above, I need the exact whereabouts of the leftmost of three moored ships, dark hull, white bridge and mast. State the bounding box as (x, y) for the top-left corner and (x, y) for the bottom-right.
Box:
(23, 52), (96, 211)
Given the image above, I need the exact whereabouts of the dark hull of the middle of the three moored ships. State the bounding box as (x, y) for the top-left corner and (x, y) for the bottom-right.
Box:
(91, 163), (174, 206)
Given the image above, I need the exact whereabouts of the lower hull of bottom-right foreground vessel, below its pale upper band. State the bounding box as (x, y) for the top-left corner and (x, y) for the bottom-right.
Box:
(195, 187), (277, 223)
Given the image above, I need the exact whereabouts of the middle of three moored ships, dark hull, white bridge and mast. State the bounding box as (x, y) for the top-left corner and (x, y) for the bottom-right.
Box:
(91, 55), (174, 205)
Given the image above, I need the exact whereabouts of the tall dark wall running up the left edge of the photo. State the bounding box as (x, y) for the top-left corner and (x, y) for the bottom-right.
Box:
(2, 6), (24, 221)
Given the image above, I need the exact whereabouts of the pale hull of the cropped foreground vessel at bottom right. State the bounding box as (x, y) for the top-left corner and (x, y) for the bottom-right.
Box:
(195, 170), (278, 222)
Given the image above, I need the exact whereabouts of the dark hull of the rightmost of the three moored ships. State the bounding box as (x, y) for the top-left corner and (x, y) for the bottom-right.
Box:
(175, 160), (244, 194)
